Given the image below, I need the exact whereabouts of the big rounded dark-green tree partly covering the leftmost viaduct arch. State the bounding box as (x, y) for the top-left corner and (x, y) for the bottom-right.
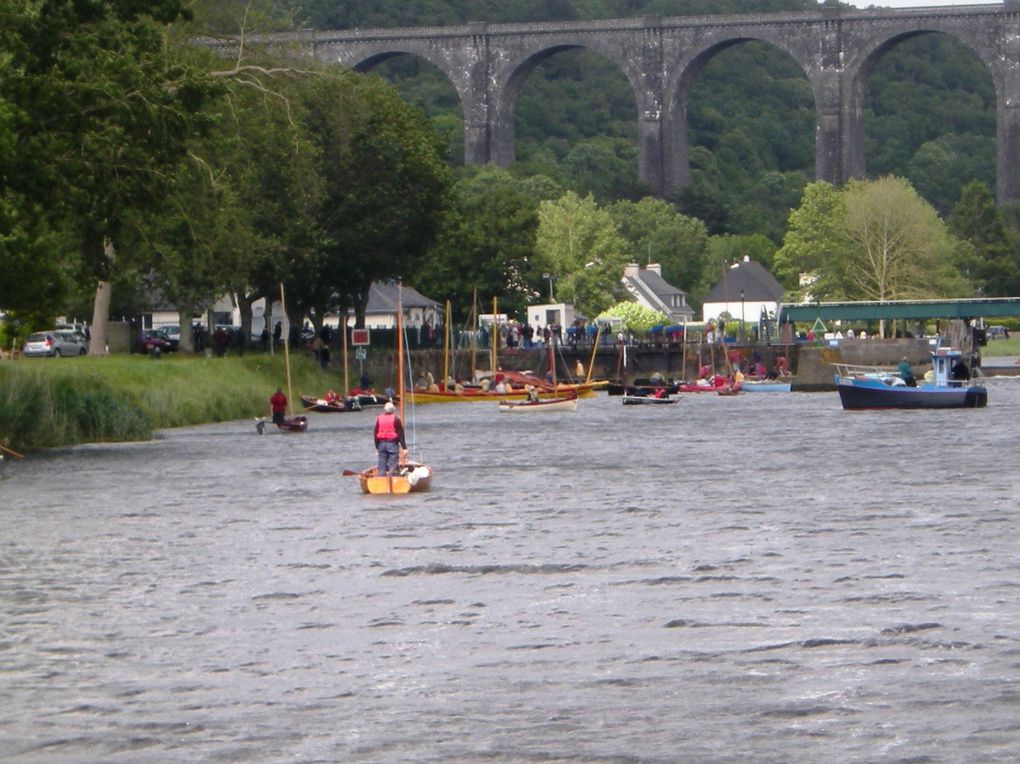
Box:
(296, 71), (452, 322)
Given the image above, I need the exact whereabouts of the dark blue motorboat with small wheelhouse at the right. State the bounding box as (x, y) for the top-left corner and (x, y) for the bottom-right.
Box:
(834, 348), (988, 410)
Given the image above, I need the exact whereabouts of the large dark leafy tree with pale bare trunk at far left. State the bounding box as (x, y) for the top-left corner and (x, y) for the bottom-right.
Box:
(4, 0), (215, 351)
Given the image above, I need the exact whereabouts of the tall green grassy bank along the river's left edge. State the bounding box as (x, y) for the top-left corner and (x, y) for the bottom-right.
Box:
(0, 354), (342, 452)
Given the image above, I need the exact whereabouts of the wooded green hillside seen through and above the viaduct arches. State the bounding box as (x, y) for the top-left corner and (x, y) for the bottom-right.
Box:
(287, 0), (996, 245)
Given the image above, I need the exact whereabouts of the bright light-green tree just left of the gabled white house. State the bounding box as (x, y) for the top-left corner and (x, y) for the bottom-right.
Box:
(536, 191), (627, 316)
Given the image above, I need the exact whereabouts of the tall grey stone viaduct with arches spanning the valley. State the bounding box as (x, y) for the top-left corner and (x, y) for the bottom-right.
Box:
(250, 0), (1020, 202)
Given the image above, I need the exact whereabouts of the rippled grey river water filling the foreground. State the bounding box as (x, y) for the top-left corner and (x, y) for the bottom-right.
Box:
(0, 379), (1020, 762)
